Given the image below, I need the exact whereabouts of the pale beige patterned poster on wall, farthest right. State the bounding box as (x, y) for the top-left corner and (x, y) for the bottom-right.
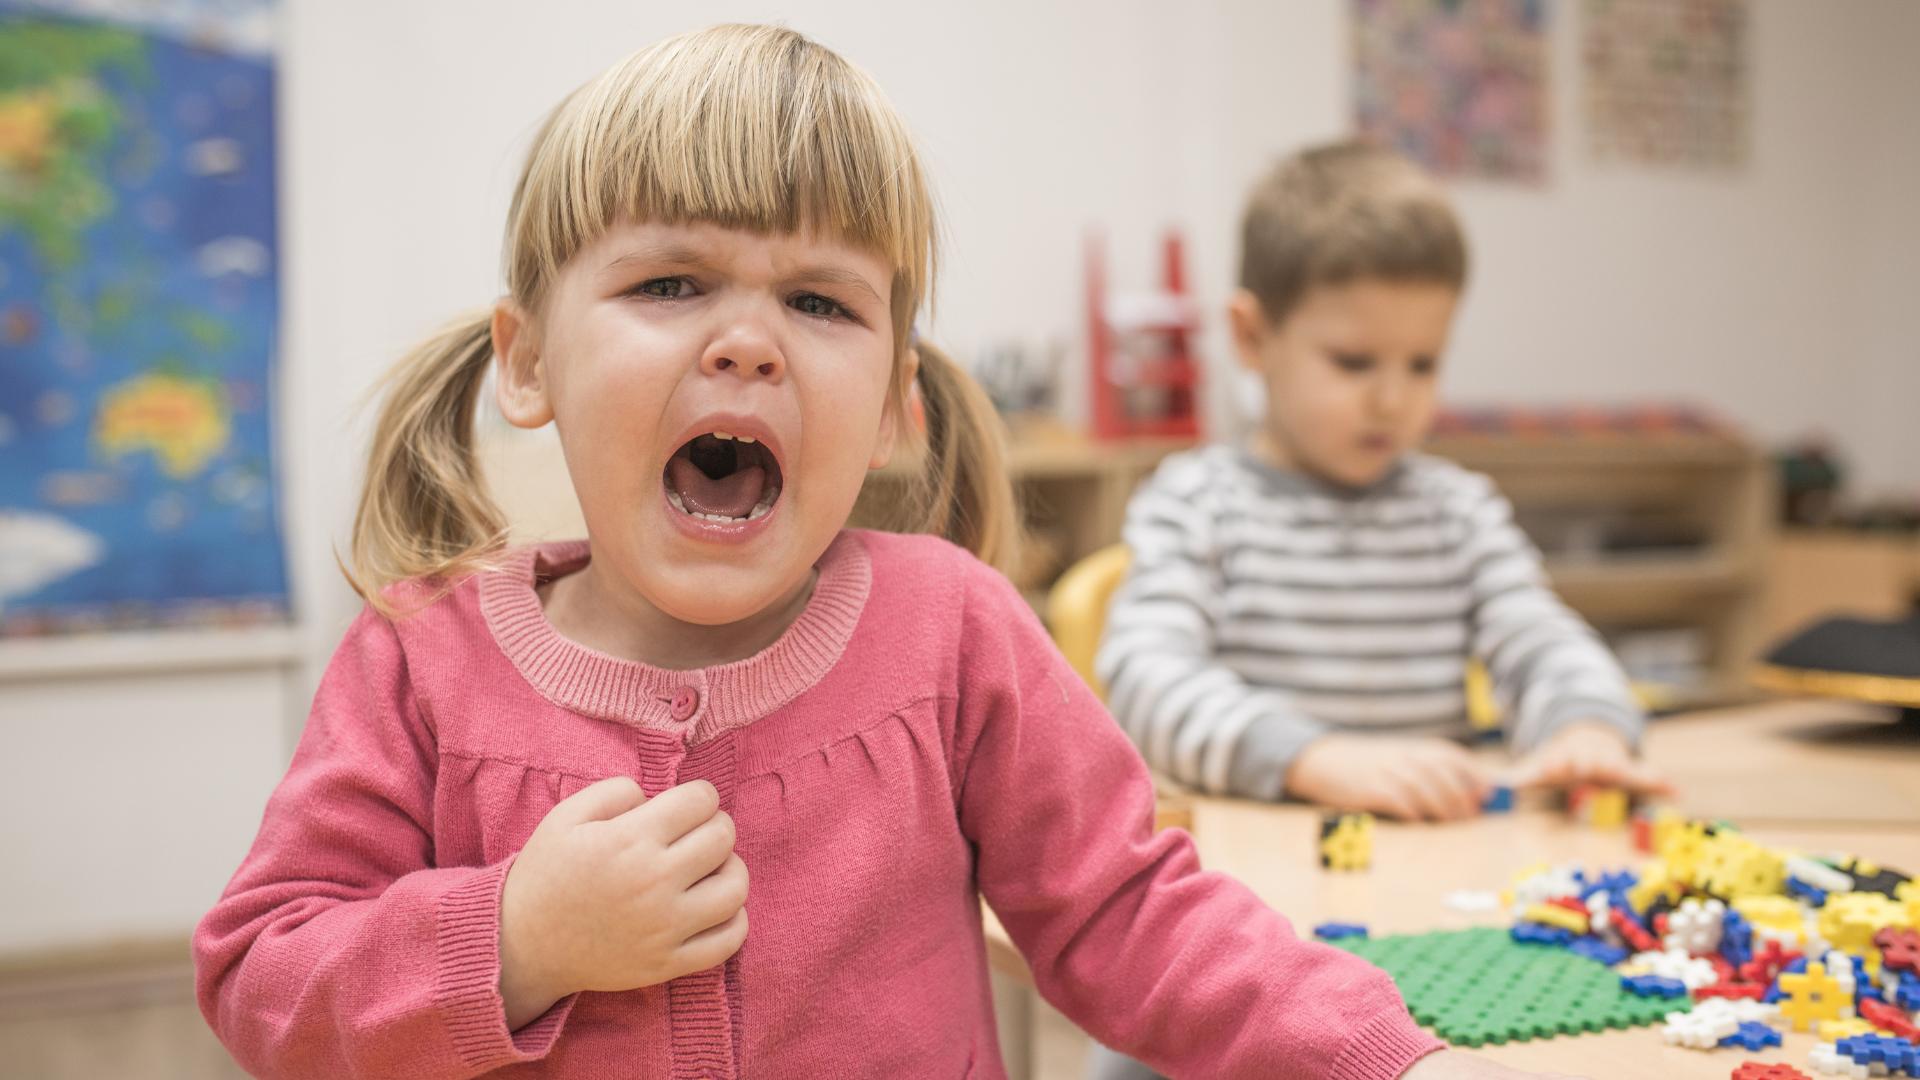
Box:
(1580, 0), (1749, 169)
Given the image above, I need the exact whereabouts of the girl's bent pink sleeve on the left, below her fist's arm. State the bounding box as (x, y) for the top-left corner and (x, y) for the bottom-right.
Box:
(194, 611), (572, 1078)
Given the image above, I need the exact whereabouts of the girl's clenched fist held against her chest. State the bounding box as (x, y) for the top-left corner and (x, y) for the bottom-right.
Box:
(499, 776), (747, 1030)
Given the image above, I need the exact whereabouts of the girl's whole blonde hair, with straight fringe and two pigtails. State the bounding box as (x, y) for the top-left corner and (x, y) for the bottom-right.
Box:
(348, 25), (1018, 605)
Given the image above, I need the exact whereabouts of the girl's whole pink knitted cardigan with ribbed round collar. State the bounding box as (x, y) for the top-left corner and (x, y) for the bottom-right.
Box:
(194, 532), (1438, 1078)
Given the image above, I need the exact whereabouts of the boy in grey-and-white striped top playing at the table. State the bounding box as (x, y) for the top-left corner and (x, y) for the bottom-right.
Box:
(1096, 142), (1665, 821)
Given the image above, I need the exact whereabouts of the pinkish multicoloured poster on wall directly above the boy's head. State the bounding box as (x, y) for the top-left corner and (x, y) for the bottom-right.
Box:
(1354, 0), (1548, 183)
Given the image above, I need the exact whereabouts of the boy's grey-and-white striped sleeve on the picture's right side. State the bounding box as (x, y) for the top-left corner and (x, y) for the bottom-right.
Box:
(1461, 477), (1645, 753)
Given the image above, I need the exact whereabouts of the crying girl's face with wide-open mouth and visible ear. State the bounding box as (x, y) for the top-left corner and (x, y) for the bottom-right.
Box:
(495, 223), (897, 626)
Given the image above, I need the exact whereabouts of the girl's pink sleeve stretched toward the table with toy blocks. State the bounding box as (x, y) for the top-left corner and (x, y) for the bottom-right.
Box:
(947, 563), (1440, 1080)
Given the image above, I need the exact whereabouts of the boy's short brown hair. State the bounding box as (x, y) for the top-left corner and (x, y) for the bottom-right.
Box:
(1240, 140), (1467, 325)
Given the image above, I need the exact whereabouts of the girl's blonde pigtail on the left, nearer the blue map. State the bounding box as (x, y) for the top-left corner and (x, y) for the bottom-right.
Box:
(342, 309), (507, 615)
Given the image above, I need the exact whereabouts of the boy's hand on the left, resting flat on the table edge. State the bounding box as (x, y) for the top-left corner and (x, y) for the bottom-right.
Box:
(1286, 734), (1490, 821)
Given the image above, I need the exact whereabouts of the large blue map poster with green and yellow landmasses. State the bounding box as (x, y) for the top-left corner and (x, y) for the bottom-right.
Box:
(0, 0), (288, 638)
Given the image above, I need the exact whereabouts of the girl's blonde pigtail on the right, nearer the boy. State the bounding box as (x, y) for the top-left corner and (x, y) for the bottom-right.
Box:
(908, 340), (1020, 575)
